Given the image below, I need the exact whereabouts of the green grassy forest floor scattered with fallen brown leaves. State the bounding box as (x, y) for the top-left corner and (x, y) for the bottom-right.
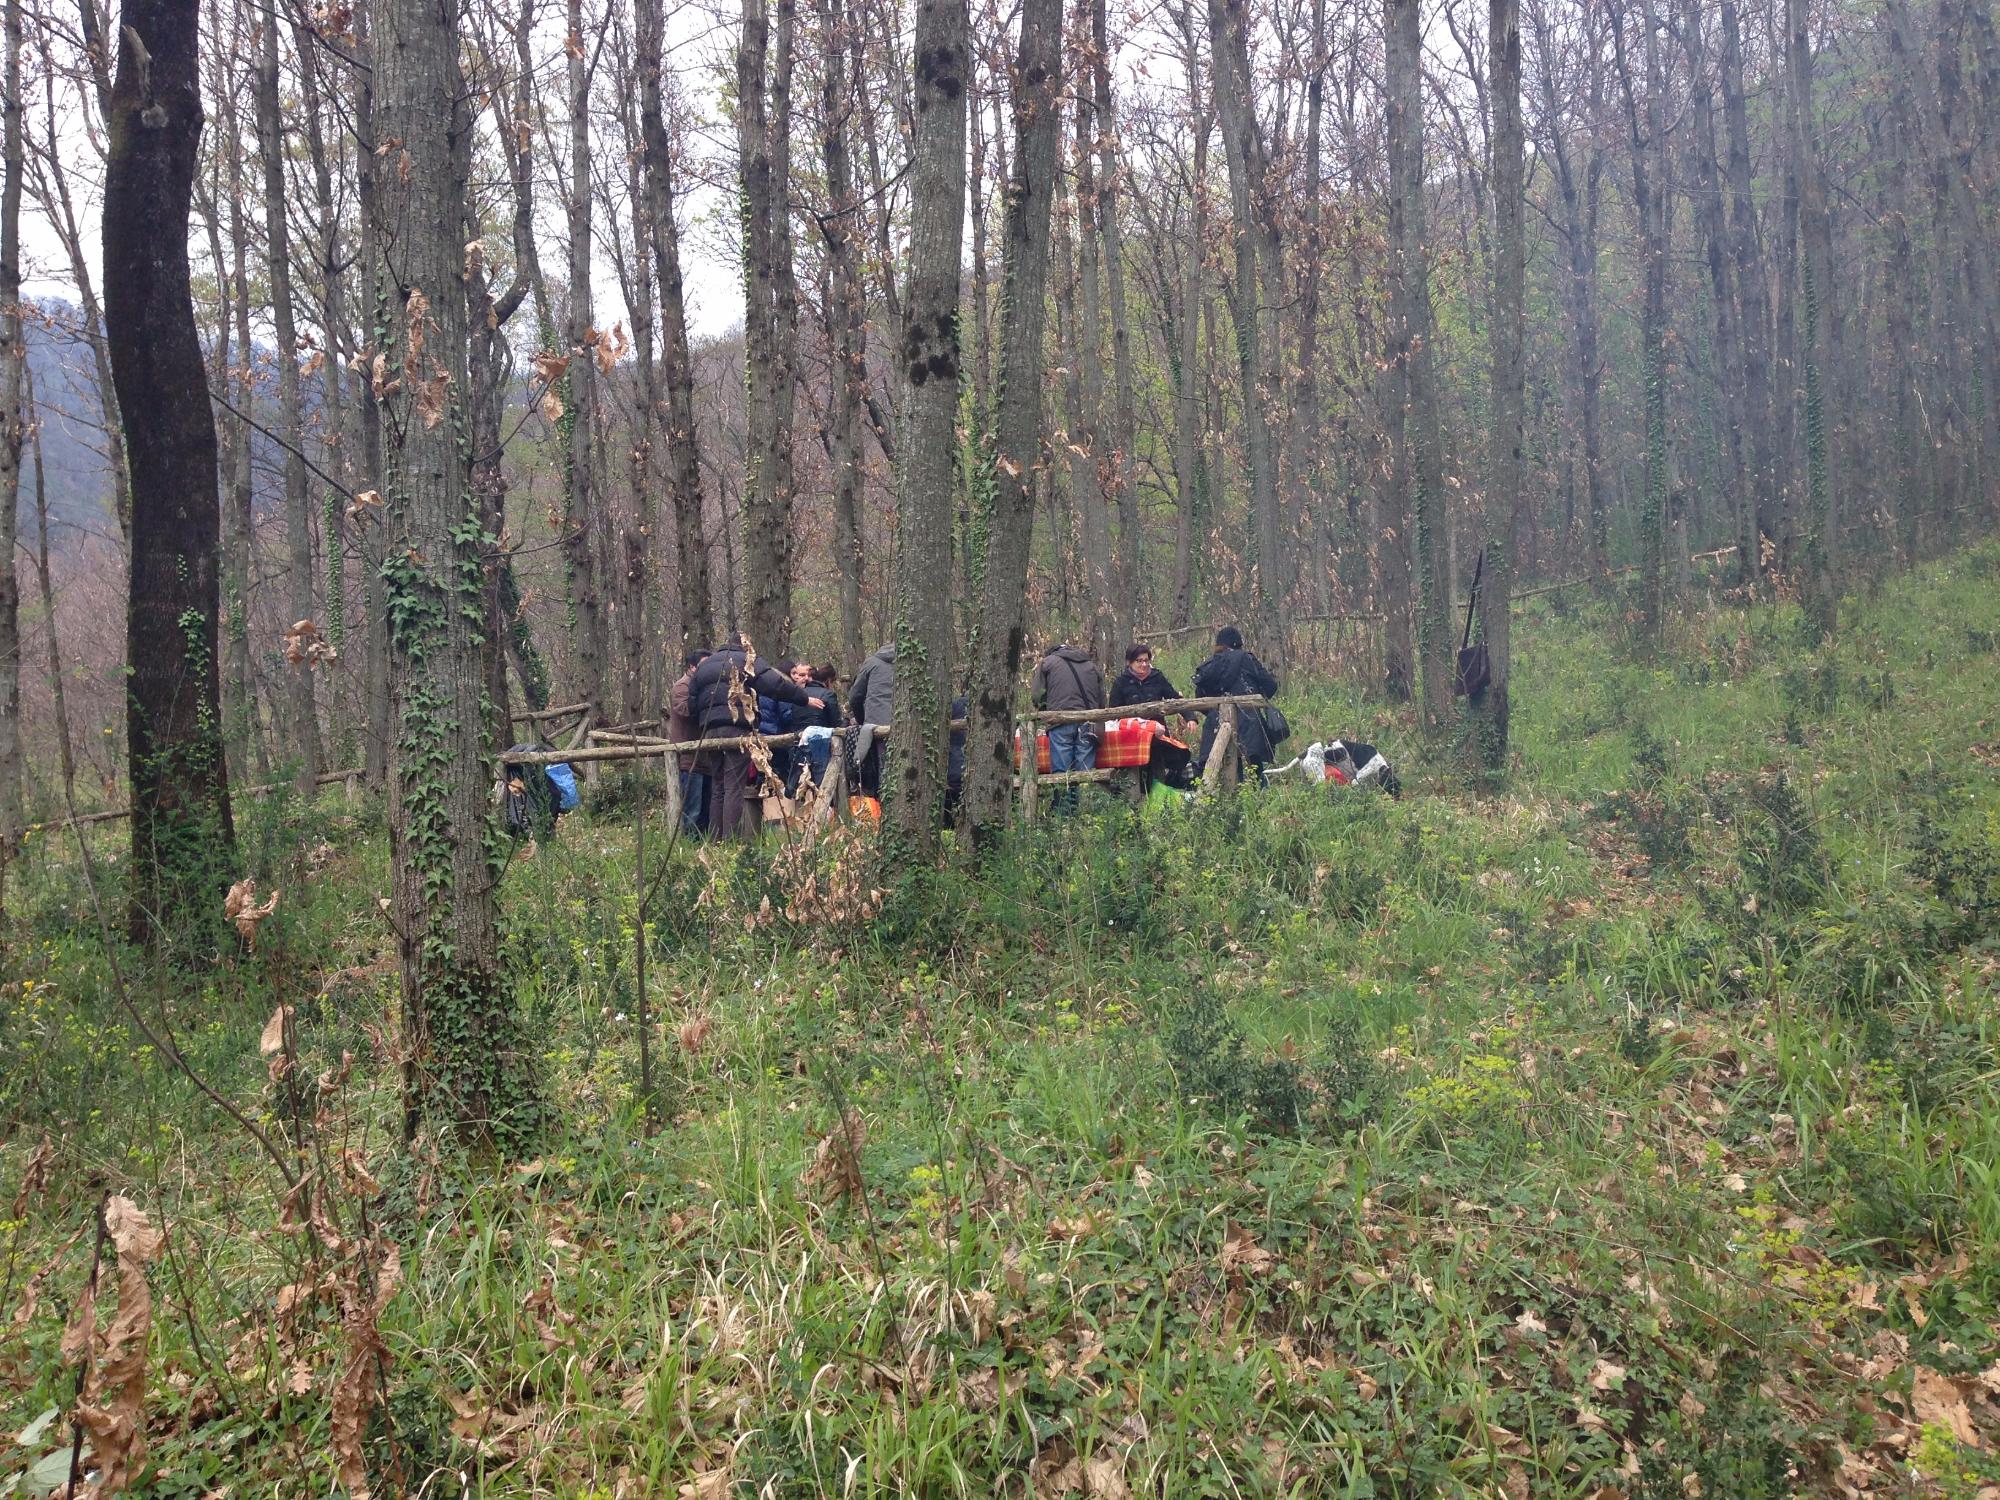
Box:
(0, 546), (2000, 1500)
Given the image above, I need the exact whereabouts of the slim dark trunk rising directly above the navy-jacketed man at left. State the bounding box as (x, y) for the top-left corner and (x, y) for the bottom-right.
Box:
(638, 0), (716, 646)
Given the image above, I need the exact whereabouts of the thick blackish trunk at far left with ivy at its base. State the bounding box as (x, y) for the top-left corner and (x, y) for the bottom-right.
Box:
(104, 0), (234, 946)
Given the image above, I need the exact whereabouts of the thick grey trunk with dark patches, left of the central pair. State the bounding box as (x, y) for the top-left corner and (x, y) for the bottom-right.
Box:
(890, 0), (972, 856)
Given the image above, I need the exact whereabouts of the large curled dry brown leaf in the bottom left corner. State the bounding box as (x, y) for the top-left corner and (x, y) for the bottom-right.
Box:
(62, 1194), (162, 1498)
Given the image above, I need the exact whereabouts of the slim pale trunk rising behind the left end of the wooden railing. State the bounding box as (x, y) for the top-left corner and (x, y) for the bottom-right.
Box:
(558, 0), (610, 712)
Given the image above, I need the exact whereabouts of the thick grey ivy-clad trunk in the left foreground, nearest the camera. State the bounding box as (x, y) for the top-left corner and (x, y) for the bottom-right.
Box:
(372, 0), (540, 1150)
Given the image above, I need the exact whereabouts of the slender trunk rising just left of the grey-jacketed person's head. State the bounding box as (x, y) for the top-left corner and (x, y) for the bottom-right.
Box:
(820, 0), (868, 662)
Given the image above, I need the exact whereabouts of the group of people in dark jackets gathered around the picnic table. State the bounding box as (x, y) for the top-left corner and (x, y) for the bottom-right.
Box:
(666, 626), (1278, 838)
